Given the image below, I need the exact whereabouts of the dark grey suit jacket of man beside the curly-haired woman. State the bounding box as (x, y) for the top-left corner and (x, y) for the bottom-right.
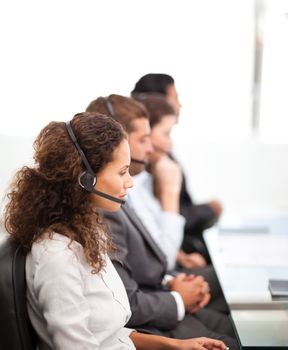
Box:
(105, 205), (178, 330)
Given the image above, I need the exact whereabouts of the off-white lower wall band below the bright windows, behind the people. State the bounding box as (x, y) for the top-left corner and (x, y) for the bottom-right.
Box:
(0, 135), (288, 226)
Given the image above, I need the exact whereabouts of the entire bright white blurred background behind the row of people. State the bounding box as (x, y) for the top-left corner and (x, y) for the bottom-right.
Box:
(0, 0), (288, 221)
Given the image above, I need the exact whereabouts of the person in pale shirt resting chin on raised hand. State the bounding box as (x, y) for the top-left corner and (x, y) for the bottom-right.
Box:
(130, 94), (207, 270)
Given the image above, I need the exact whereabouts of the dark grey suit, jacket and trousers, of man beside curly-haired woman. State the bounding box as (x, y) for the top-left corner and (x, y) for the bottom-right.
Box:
(104, 205), (235, 349)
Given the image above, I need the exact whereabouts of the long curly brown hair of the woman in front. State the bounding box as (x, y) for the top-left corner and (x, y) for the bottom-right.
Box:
(4, 112), (127, 273)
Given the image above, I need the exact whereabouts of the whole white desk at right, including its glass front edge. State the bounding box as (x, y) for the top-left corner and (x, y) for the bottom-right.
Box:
(204, 227), (288, 349)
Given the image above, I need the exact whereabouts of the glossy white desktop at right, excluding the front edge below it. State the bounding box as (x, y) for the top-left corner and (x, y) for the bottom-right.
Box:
(204, 228), (288, 306)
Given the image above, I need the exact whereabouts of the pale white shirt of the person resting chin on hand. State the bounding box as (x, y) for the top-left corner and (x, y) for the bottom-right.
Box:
(129, 171), (185, 270)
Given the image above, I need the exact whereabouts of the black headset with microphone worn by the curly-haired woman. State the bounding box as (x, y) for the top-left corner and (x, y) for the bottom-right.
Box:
(66, 121), (125, 204)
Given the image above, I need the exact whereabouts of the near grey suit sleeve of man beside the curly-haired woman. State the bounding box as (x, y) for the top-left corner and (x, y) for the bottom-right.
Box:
(105, 210), (178, 330)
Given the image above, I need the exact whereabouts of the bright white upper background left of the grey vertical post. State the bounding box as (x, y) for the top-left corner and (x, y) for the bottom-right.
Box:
(0, 0), (254, 140)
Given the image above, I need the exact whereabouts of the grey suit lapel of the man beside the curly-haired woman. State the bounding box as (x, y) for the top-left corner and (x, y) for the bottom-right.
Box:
(122, 205), (167, 266)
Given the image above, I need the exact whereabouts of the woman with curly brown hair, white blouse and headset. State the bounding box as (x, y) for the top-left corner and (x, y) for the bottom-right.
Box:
(5, 112), (225, 350)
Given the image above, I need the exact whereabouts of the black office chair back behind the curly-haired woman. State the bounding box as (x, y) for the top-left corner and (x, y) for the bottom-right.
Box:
(0, 238), (36, 350)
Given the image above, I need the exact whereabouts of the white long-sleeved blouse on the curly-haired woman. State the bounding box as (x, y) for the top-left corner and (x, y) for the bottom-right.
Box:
(26, 233), (135, 350)
